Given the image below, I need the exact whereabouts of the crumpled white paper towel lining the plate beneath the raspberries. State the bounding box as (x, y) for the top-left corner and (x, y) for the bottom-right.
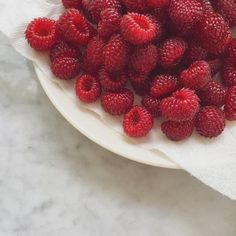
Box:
(0, 0), (236, 200)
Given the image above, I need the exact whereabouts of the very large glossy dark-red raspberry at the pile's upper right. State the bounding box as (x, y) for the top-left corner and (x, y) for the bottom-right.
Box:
(195, 12), (232, 54)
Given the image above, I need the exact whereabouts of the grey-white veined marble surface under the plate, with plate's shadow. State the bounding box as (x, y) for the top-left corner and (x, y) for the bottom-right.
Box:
(0, 31), (236, 236)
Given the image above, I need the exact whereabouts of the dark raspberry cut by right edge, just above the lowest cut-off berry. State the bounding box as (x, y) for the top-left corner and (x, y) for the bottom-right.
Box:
(221, 58), (236, 87)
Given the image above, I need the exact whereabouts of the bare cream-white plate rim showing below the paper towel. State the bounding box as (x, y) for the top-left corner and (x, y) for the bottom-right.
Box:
(34, 65), (180, 169)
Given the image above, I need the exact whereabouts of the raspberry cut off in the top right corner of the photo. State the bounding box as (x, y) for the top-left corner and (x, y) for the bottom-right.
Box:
(212, 0), (236, 26)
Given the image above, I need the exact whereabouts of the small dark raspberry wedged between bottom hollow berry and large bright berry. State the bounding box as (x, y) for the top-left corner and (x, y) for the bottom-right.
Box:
(141, 95), (161, 117)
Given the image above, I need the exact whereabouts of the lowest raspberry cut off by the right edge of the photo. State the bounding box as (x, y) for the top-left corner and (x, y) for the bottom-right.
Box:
(224, 86), (236, 120)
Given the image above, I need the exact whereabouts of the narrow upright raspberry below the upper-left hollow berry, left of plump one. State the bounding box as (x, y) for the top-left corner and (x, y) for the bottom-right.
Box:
(85, 36), (105, 68)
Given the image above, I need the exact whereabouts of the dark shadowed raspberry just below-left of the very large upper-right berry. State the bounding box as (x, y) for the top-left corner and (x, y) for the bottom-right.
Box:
(183, 40), (207, 65)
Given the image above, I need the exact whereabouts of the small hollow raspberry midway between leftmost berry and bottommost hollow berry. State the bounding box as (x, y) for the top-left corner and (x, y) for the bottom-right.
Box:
(75, 75), (101, 103)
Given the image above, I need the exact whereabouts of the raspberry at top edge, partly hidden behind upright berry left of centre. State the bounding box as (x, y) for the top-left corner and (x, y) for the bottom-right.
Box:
(89, 0), (120, 22)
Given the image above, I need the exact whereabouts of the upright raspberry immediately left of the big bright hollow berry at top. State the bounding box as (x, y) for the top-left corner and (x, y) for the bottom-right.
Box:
(98, 8), (121, 38)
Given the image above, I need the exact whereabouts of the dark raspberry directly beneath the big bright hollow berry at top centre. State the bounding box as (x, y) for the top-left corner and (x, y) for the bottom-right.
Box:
(131, 44), (158, 74)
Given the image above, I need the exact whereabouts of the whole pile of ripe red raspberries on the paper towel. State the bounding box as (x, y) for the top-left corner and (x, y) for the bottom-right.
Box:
(25, 0), (236, 141)
